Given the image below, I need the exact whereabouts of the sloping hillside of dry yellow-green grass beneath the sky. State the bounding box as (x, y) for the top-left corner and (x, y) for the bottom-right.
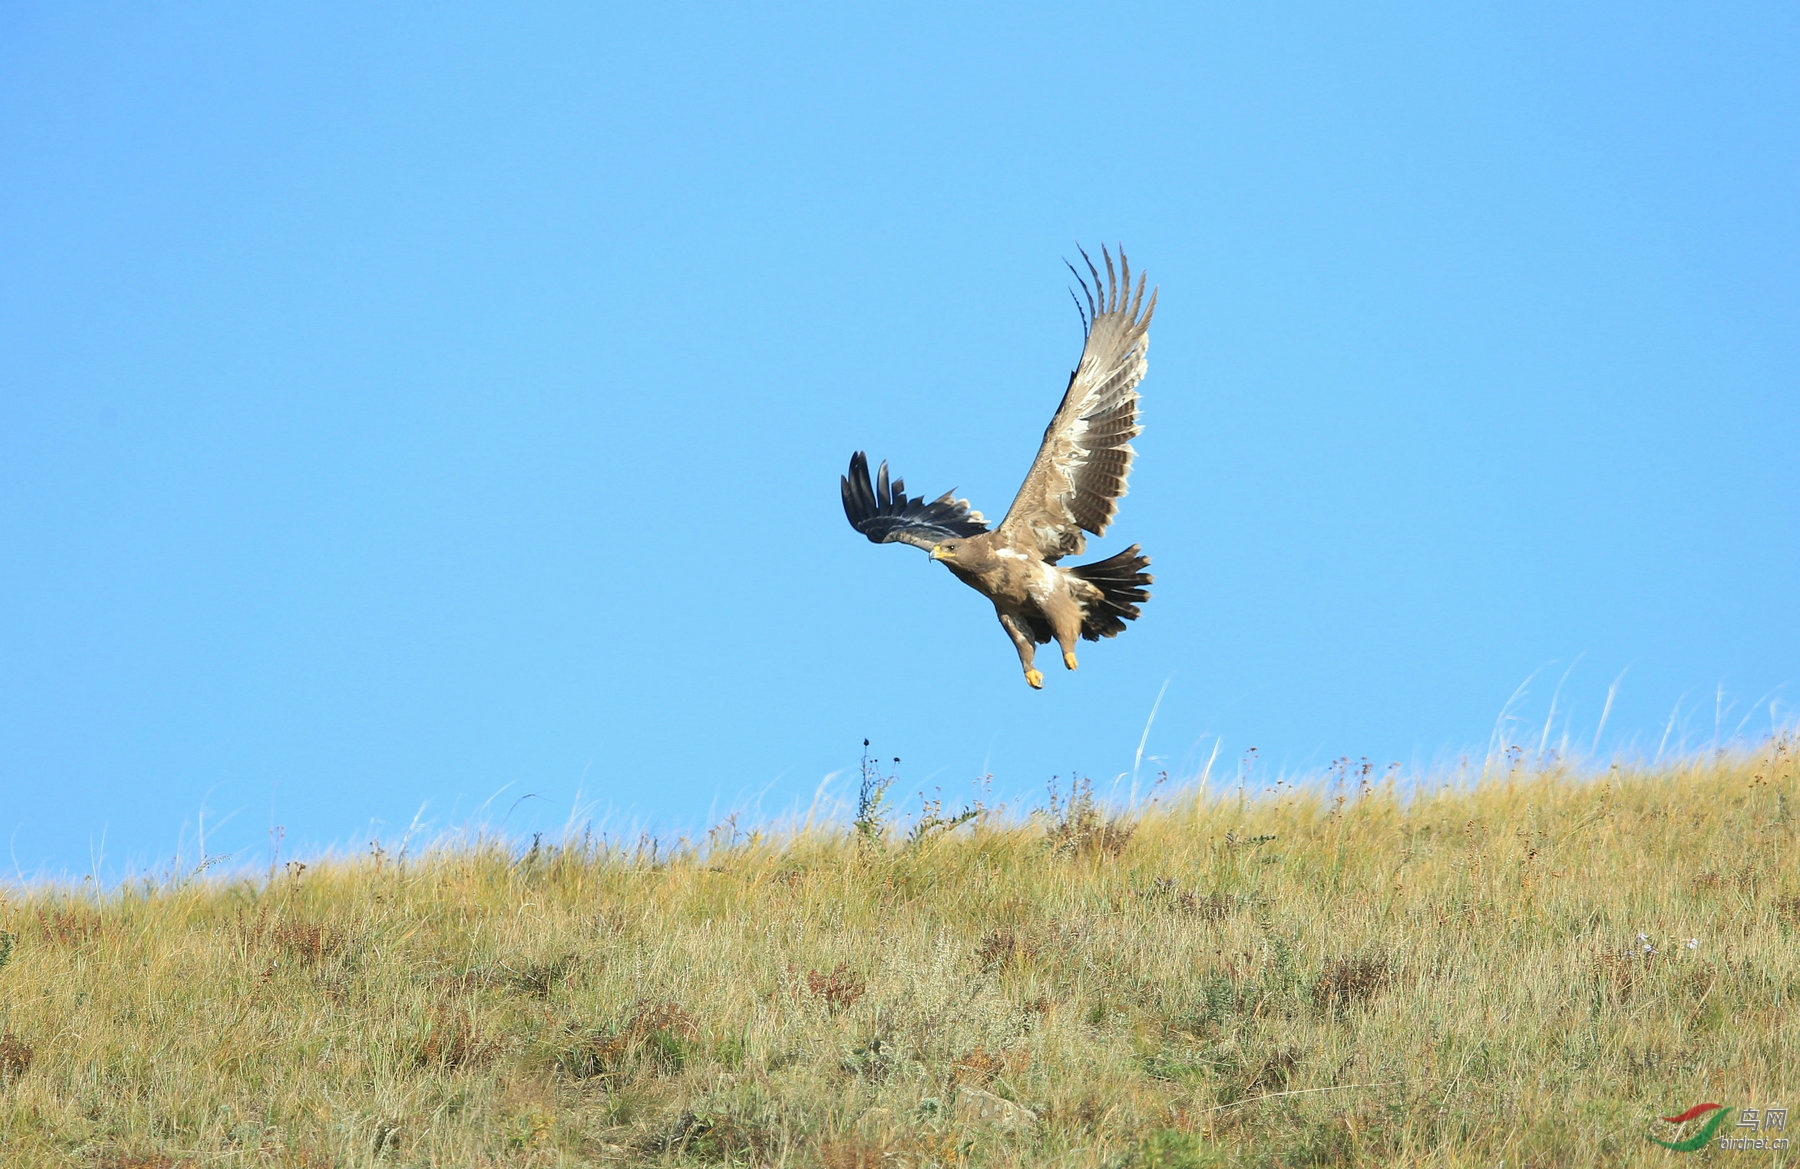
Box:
(0, 739), (1800, 1169)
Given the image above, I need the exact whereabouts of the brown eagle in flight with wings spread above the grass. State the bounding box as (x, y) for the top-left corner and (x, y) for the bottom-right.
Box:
(841, 247), (1156, 690)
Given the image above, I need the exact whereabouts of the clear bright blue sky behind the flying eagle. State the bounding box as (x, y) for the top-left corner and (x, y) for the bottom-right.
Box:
(0, 4), (1800, 875)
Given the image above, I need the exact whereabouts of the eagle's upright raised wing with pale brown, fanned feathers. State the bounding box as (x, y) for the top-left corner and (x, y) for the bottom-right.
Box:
(999, 249), (1156, 564)
